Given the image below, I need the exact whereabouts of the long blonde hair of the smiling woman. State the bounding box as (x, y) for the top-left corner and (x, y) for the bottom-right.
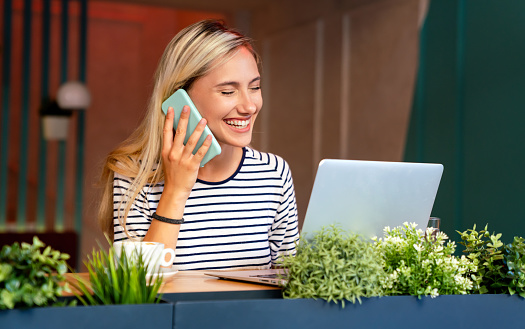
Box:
(98, 20), (260, 238)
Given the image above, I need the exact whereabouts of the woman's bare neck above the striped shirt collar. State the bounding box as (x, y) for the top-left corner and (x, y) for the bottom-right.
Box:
(197, 145), (243, 182)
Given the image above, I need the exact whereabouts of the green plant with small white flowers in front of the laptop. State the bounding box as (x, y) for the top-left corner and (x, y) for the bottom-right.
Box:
(375, 223), (475, 298)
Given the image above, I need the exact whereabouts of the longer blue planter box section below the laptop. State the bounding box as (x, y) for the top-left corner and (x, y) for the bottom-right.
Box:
(174, 295), (525, 329)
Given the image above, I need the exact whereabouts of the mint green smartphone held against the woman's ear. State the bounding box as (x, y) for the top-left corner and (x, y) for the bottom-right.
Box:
(162, 89), (221, 167)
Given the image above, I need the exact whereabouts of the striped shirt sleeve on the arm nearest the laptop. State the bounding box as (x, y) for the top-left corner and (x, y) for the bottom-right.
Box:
(269, 160), (299, 264)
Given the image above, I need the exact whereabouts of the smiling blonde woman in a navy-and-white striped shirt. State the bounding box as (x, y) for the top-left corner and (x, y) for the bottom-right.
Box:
(99, 21), (299, 270)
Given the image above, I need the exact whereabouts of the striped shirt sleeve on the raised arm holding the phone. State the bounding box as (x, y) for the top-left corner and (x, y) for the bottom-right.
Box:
(113, 173), (152, 242)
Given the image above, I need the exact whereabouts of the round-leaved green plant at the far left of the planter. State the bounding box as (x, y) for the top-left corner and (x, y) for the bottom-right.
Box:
(0, 236), (69, 309)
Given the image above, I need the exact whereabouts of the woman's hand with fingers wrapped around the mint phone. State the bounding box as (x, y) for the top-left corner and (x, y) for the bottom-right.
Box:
(161, 105), (212, 199)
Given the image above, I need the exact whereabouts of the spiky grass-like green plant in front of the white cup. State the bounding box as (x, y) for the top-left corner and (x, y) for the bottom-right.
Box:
(72, 242), (162, 305)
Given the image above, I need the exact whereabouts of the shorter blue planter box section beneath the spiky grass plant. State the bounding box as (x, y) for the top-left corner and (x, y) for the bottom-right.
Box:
(0, 303), (173, 329)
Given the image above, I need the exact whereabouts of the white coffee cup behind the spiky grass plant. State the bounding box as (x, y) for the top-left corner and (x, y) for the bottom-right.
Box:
(113, 241), (175, 274)
